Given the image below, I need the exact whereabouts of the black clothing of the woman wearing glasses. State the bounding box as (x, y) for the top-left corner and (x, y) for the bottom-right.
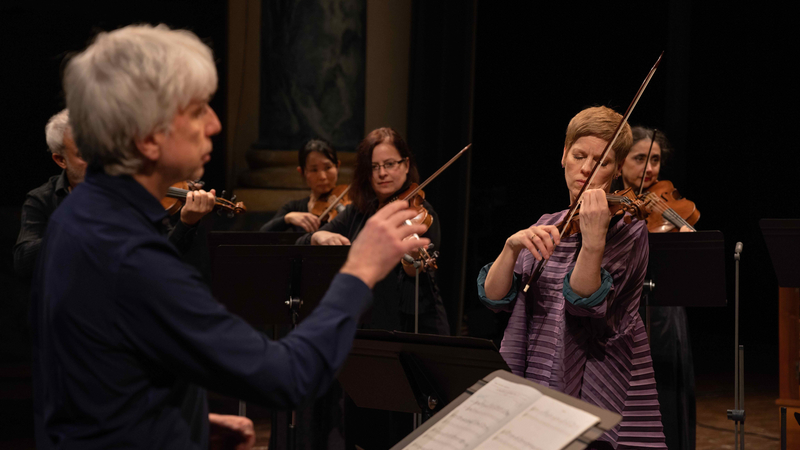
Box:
(297, 201), (450, 335)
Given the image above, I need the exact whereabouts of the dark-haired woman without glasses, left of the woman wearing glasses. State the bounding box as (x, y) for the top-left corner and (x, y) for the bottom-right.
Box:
(261, 139), (342, 232)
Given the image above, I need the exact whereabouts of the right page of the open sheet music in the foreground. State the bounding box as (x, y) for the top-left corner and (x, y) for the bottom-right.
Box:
(476, 396), (600, 450)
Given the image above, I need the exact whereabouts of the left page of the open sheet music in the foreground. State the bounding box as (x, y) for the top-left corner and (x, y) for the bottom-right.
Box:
(406, 377), (543, 450)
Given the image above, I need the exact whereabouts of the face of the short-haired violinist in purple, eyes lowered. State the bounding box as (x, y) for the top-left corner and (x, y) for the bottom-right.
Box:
(561, 136), (617, 204)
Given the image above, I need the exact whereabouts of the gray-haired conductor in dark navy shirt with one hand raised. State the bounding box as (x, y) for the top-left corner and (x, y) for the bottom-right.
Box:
(31, 25), (428, 449)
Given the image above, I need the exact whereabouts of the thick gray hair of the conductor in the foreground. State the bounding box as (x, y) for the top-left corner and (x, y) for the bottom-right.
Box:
(64, 24), (217, 175)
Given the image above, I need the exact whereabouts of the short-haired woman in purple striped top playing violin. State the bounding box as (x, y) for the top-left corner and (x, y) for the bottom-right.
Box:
(478, 107), (666, 449)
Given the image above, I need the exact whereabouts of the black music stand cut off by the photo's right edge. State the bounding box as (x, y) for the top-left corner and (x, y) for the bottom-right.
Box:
(759, 219), (800, 287)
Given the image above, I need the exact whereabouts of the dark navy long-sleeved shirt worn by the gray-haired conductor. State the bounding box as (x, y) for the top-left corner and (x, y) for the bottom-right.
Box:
(31, 173), (372, 449)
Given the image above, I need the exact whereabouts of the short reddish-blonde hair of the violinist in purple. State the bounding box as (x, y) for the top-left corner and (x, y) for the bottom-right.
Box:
(564, 106), (633, 166)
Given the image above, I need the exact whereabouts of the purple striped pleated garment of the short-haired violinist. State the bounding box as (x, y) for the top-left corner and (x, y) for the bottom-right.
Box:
(484, 211), (666, 449)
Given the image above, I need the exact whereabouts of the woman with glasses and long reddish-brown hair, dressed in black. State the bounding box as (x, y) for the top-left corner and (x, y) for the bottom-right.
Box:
(297, 128), (450, 335)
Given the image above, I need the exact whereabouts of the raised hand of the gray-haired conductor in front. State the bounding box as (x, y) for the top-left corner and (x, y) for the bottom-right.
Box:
(342, 201), (431, 289)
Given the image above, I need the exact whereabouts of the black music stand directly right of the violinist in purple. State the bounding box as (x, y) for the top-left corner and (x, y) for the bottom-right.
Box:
(645, 231), (727, 306)
